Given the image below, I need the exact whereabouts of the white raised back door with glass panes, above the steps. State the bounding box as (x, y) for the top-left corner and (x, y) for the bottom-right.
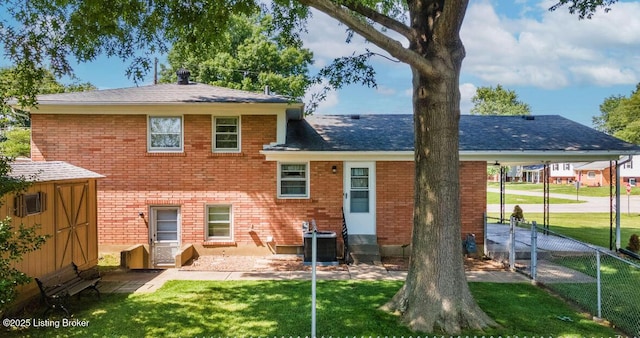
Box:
(344, 162), (376, 235)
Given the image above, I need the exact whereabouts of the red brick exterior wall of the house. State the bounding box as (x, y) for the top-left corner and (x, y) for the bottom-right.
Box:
(32, 114), (486, 247)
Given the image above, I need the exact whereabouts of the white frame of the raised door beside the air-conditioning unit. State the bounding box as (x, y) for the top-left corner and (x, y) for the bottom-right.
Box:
(343, 162), (376, 235)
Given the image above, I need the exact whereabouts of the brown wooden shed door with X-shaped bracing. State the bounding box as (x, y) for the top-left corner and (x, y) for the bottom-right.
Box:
(54, 182), (89, 268)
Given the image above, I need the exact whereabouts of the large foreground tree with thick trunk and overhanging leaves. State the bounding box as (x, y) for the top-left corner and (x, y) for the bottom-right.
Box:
(0, 0), (616, 334)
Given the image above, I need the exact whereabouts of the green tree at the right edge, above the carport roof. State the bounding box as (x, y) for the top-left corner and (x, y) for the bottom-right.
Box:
(593, 83), (640, 144)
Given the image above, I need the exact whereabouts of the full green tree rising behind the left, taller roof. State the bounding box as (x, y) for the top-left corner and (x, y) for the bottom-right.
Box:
(160, 14), (313, 99)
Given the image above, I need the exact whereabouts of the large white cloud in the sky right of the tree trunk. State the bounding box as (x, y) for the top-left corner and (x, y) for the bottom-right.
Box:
(461, 1), (640, 89)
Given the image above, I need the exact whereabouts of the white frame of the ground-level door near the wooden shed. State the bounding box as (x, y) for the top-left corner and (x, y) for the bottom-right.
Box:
(149, 205), (181, 266)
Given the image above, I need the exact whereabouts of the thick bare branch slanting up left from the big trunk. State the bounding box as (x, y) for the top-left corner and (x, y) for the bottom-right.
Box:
(299, 0), (438, 77)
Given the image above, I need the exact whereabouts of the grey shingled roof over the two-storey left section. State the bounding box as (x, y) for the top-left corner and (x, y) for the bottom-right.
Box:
(33, 83), (291, 105)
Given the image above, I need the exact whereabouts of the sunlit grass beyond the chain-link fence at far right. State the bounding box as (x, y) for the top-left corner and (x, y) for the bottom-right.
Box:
(489, 210), (640, 248)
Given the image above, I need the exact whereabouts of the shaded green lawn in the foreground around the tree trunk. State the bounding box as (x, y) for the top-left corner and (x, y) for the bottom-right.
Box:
(3, 281), (618, 337)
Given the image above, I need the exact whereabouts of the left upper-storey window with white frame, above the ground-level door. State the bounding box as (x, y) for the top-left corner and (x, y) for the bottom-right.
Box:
(148, 116), (184, 152)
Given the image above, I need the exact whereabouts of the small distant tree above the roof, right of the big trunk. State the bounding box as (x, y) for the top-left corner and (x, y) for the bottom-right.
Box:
(471, 84), (531, 115)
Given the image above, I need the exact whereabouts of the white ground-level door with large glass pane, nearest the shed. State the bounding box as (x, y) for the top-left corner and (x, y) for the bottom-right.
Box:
(150, 207), (180, 266)
